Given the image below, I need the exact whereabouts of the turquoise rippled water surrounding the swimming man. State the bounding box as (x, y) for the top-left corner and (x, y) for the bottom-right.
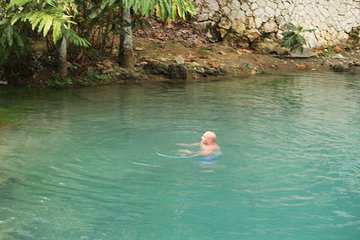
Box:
(0, 73), (360, 240)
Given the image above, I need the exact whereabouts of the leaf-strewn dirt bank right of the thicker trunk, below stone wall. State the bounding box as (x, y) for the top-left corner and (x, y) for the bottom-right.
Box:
(112, 19), (360, 81)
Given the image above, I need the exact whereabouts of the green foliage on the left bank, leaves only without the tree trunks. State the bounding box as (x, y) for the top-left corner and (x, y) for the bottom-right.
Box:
(0, 0), (194, 82)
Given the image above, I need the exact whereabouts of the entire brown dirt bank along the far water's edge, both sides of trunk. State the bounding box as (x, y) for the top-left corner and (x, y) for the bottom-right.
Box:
(3, 21), (360, 87)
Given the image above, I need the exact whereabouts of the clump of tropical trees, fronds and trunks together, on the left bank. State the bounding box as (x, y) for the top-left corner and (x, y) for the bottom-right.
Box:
(0, 0), (194, 82)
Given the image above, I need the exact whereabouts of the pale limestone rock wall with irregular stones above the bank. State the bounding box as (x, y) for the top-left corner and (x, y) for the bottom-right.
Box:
(194, 0), (360, 47)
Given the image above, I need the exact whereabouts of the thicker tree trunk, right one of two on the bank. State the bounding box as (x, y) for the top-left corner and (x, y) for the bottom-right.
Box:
(118, 7), (135, 71)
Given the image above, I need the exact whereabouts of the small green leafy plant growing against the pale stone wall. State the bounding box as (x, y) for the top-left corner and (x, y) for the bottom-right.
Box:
(281, 23), (315, 53)
